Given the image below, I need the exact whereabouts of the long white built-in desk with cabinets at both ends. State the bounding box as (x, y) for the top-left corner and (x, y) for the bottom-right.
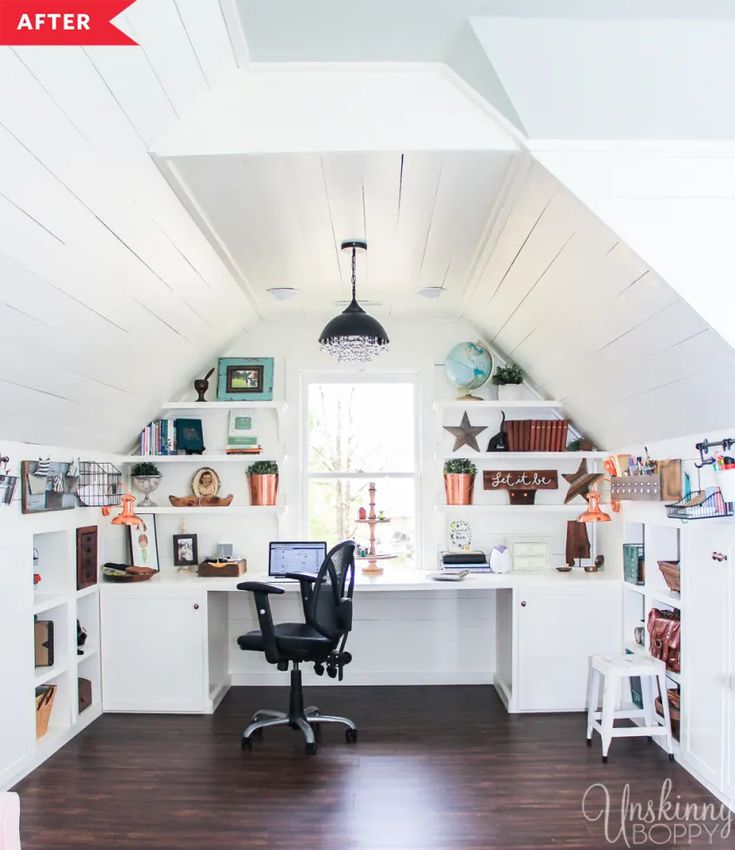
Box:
(101, 567), (622, 713)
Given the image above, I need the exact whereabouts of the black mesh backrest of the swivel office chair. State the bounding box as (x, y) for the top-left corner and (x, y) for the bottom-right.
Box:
(304, 540), (355, 639)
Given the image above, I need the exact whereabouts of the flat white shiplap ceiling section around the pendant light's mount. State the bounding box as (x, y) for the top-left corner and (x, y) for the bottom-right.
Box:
(162, 151), (513, 315)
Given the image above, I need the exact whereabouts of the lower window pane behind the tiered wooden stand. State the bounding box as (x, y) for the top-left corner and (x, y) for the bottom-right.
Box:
(308, 478), (416, 563)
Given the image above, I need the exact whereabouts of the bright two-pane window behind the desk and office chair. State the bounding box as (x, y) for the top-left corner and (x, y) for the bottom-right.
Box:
(304, 377), (418, 563)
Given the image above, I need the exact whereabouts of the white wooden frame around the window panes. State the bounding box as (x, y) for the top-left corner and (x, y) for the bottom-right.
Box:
(299, 371), (423, 552)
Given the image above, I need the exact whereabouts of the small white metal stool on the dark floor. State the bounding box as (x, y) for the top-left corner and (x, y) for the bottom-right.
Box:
(587, 654), (674, 762)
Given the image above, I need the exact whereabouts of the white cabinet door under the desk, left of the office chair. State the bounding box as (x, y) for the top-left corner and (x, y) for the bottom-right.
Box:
(101, 588), (207, 712)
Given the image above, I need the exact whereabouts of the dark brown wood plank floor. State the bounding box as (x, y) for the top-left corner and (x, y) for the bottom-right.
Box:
(16, 686), (733, 850)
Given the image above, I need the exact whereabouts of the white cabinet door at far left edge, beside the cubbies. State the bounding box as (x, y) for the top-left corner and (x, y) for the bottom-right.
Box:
(0, 546), (35, 787)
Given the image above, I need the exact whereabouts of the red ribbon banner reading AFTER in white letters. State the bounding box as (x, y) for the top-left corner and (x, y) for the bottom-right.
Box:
(0, 0), (137, 46)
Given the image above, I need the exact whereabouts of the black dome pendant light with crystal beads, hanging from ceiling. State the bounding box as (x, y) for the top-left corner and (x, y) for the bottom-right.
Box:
(319, 241), (390, 363)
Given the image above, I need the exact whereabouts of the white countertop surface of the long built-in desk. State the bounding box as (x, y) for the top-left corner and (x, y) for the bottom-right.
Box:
(103, 567), (622, 595)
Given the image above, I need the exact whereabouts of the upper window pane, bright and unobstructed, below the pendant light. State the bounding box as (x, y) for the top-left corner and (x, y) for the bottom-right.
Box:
(308, 383), (416, 472)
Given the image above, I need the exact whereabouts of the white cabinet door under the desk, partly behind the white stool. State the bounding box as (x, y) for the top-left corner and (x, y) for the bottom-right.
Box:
(516, 587), (622, 711)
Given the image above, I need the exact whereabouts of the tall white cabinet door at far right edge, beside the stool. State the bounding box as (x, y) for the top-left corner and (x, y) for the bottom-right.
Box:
(681, 527), (733, 787)
